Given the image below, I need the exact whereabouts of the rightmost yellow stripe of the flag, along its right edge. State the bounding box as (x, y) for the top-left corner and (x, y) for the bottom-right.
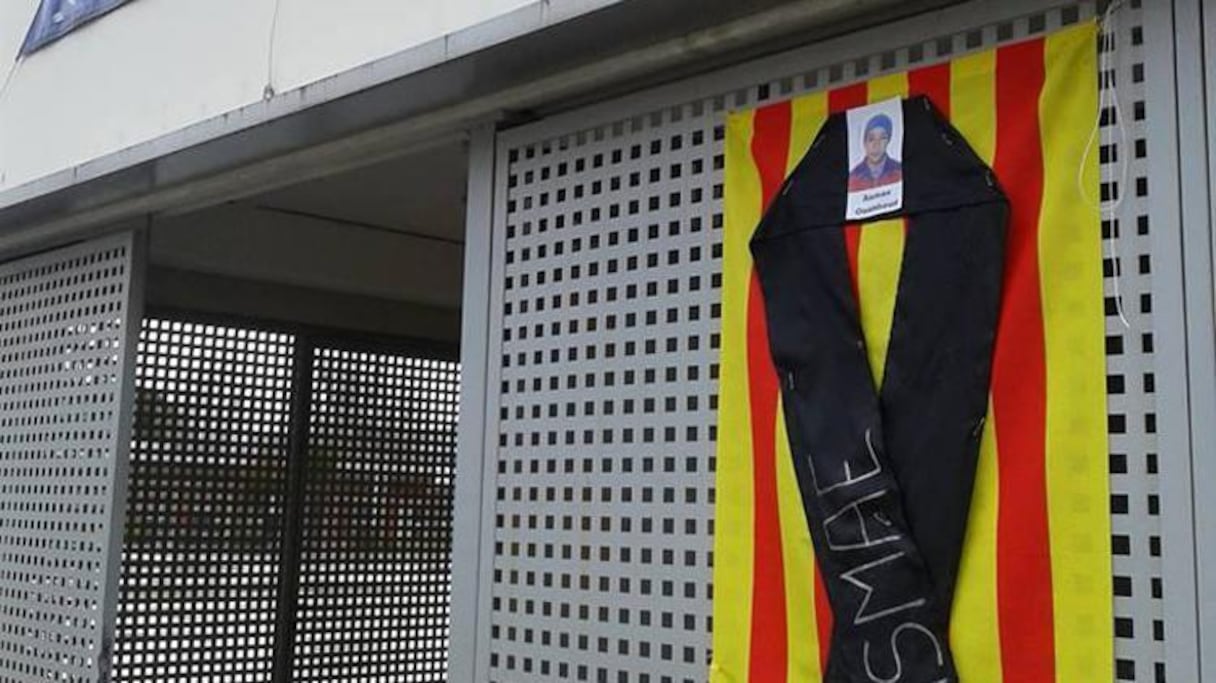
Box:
(1038, 18), (1114, 681)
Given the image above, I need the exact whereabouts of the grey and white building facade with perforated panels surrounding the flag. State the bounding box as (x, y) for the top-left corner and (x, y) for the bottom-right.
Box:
(0, 0), (1216, 683)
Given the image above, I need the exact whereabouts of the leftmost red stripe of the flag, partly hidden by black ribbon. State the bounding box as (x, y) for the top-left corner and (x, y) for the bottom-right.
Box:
(748, 102), (792, 683)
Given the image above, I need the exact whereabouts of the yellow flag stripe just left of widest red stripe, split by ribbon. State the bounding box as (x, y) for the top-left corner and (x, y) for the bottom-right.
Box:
(950, 45), (1002, 683)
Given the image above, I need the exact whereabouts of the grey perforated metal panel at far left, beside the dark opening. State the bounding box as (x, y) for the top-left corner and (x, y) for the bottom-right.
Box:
(0, 235), (140, 683)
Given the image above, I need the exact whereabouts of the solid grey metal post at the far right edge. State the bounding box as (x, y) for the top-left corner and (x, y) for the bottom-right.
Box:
(1144, 0), (1214, 681)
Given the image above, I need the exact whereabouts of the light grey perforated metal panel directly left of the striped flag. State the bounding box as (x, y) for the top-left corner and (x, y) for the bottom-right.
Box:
(490, 48), (722, 683)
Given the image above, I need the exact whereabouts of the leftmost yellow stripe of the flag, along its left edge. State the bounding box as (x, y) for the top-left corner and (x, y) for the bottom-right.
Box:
(710, 112), (761, 683)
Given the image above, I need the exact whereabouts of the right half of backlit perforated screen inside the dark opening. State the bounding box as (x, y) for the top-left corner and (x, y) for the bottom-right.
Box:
(293, 346), (460, 683)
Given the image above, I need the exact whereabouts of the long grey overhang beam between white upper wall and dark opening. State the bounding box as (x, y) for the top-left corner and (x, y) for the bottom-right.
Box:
(0, 0), (953, 254)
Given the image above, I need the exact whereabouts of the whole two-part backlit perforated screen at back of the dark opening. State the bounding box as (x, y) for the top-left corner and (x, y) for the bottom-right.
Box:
(111, 314), (460, 683)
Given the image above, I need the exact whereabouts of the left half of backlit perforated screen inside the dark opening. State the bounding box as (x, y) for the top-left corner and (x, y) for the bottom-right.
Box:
(116, 318), (294, 683)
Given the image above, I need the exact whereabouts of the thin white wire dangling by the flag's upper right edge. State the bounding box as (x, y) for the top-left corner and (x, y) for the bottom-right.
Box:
(1076, 0), (1132, 329)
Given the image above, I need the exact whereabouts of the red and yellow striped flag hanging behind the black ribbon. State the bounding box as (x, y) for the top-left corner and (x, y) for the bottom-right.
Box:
(711, 23), (1114, 683)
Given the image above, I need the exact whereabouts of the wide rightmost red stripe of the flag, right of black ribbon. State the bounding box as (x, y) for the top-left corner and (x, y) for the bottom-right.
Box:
(992, 39), (1055, 683)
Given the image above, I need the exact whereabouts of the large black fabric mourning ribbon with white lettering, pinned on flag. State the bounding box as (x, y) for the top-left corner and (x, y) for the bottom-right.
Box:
(751, 97), (1008, 683)
